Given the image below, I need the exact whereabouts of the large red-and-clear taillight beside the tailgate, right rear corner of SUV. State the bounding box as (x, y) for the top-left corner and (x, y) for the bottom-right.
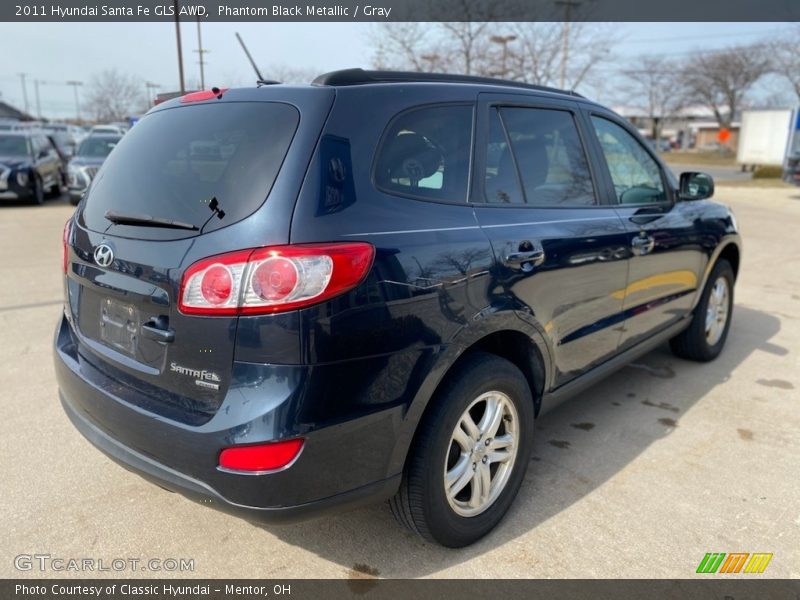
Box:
(179, 242), (375, 315)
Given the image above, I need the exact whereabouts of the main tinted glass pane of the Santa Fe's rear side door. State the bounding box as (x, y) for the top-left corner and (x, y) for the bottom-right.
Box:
(500, 108), (596, 206)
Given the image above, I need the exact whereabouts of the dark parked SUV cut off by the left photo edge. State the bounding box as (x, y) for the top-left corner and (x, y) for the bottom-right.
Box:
(0, 131), (65, 204)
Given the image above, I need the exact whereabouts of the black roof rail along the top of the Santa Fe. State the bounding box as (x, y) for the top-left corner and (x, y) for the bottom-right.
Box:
(311, 69), (584, 98)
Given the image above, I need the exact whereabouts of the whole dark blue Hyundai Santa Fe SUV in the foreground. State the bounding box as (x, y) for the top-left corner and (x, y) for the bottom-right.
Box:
(55, 69), (740, 547)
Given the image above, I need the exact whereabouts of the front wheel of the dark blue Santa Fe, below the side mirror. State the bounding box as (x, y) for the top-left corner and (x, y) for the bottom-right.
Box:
(669, 259), (734, 362)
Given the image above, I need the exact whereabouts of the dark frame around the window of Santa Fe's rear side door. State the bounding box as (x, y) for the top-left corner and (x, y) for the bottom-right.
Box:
(469, 97), (611, 210)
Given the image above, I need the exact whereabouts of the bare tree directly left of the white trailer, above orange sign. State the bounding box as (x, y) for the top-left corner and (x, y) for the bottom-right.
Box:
(682, 44), (771, 127)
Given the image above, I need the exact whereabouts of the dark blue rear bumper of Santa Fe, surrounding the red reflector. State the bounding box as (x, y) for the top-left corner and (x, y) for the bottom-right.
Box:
(54, 317), (401, 522)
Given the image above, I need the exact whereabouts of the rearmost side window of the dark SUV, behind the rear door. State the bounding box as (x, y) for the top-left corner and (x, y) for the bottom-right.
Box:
(375, 105), (472, 202)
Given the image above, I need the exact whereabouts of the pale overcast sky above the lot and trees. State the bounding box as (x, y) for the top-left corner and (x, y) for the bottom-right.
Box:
(0, 22), (787, 118)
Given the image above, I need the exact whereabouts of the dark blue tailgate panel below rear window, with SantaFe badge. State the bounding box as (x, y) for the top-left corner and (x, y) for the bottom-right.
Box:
(67, 230), (236, 423)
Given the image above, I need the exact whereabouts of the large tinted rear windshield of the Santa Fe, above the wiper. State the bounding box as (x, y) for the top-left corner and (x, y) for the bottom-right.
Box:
(83, 102), (300, 239)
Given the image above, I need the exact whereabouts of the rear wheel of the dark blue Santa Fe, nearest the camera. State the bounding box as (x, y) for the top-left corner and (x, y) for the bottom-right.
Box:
(389, 352), (534, 548)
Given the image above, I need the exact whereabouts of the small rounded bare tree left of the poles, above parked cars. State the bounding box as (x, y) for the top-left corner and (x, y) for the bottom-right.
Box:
(86, 69), (147, 121)
